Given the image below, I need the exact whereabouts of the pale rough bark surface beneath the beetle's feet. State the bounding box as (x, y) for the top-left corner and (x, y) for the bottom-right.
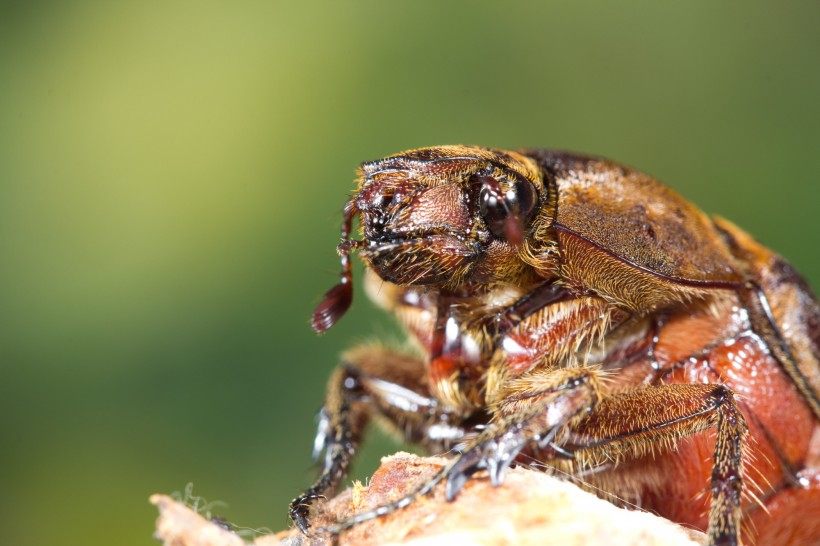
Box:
(151, 453), (704, 546)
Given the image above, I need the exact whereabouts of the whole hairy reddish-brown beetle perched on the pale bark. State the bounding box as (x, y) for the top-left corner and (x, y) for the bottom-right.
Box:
(290, 146), (820, 544)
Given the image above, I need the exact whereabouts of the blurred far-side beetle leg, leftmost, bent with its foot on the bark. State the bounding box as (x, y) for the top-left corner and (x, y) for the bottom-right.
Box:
(289, 346), (464, 534)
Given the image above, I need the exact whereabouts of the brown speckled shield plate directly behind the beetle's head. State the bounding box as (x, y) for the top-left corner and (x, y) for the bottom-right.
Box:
(523, 150), (744, 288)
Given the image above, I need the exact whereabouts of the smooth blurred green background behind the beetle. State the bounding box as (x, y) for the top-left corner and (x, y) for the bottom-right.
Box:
(0, 0), (820, 545)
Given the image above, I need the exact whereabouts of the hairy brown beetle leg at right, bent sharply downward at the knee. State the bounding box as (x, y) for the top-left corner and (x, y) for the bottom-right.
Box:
(544, 384), (747, 545)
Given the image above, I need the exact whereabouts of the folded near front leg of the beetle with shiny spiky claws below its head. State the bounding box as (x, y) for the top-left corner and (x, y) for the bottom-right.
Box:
(446, 298), (629, 492)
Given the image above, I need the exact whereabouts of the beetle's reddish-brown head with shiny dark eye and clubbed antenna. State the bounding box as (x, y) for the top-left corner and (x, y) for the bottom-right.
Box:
(313, 146), (548, 332)
